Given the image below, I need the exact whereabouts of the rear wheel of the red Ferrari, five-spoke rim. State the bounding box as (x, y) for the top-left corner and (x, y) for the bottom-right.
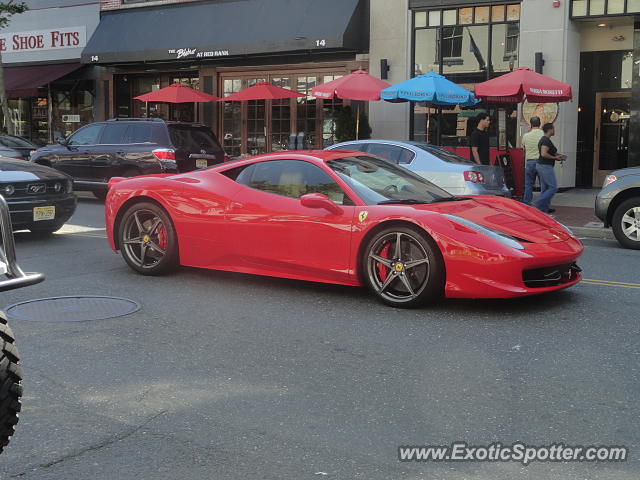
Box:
(118, 202), (178, 275)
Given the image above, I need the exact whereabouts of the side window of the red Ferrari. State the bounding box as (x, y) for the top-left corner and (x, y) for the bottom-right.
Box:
(228, 160), (353, 205)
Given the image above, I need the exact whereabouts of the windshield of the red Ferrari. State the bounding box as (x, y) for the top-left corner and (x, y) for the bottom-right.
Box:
(327, 156), (451, 205)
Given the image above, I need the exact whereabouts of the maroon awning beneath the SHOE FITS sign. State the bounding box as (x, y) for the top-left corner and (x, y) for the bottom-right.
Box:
(4, 63), (83, 98)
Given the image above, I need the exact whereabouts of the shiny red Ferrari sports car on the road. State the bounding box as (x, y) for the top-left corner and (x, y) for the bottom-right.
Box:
(105, 150), (583, 307)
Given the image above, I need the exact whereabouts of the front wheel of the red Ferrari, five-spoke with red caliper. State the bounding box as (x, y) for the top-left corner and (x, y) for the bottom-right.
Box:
(361, 227), (445, 308)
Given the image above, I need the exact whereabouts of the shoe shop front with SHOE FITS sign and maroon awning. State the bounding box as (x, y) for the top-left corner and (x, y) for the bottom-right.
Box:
(0, 0), (99, 144)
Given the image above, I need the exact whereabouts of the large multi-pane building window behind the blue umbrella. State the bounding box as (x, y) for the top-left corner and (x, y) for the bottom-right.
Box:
(411, 1), (520, 146)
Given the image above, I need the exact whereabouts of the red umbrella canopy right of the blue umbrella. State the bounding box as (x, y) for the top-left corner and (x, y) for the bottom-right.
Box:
(475, 67), (572, 103)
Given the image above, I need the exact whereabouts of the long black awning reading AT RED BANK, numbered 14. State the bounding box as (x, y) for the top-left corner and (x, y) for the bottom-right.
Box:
(81, 0), (369, 63)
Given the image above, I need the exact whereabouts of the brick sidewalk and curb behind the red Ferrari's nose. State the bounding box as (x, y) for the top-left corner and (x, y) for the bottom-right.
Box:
(533, 188), (614, 239)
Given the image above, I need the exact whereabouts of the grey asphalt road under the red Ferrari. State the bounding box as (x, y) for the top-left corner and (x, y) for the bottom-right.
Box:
(0, 199), (640, 480)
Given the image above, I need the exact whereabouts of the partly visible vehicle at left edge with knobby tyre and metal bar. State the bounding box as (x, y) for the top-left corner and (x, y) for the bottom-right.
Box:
(0, 196), (44, 453)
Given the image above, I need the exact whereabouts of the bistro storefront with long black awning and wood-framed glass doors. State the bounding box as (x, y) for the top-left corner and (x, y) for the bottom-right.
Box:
(83, 0), (368, 156)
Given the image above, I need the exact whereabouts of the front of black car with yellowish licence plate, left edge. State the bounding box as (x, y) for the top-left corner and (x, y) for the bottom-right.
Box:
(0, 158), (77, 234)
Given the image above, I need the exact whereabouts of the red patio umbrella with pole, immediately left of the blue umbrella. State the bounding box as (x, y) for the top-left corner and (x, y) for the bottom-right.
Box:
(311, 70), (391, 140)
